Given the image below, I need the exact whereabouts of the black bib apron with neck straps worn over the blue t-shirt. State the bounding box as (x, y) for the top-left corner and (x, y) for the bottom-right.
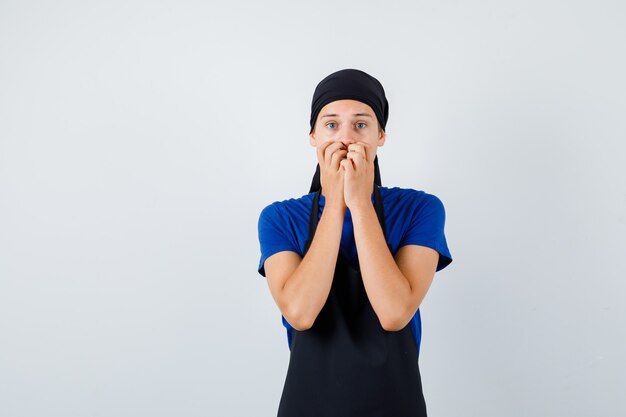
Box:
(278, 185), (426, 417)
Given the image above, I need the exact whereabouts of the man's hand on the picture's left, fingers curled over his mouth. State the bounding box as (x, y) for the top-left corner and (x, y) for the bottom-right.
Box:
(317, 140), (348, 210)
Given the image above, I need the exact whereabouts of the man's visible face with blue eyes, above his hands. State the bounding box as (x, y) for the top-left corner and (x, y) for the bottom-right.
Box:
(309, 100), (385, 160)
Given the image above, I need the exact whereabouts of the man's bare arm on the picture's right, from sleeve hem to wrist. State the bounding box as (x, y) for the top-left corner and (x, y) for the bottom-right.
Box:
(351, 204), (439, 331)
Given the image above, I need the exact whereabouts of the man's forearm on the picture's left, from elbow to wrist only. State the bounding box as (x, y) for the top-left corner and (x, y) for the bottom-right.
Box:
(283, 207), (345, 330)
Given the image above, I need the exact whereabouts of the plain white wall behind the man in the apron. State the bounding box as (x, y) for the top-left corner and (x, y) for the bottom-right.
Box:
(0, 0), (626, 417)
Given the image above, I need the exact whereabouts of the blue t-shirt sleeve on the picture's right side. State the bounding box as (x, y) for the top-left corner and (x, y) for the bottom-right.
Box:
(398, 194), (452, 271)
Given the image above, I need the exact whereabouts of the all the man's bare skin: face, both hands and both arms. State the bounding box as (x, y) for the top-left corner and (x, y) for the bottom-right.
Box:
(265, 100), (439, 331)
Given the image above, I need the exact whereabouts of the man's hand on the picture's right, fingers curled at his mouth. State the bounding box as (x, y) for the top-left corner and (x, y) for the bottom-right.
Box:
(340, 143), (374, 211)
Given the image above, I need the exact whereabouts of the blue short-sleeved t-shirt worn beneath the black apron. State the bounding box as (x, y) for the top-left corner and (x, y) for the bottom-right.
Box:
(258, 187), (452, 351)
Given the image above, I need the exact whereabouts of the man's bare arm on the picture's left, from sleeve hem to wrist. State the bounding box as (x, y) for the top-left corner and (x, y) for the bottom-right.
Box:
(265, 203), (345, 330)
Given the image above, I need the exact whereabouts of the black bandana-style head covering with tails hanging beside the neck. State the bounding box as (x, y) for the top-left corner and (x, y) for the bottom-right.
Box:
(309, 68), (389, 193)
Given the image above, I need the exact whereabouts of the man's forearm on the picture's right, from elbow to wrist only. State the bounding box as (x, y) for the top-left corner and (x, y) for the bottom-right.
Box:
(350, 204), (412, 330)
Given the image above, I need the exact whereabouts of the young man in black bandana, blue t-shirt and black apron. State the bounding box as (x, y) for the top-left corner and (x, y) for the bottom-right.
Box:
(258, 69), (452, 417)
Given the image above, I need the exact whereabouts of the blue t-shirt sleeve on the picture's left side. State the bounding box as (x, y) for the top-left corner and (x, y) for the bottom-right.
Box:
(258, 203), (300, 276)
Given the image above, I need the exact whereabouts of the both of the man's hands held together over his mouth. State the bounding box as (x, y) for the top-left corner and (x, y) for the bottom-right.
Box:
(317, 141), (374, 211)
